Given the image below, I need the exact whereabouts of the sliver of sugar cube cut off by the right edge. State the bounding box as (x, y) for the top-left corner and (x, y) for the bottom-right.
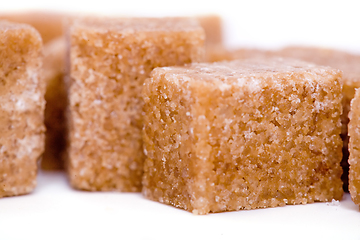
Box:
(349, 89), (360, 205)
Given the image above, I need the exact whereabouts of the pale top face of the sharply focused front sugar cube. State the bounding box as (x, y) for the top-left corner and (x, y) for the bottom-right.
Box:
(152, 57), (341, 91)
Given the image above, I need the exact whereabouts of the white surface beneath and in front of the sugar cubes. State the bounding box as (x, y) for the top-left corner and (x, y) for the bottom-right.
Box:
(0, 172), (360, 240)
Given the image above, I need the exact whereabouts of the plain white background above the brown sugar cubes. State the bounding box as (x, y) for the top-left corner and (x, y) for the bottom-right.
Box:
(0, 0), (360, 53)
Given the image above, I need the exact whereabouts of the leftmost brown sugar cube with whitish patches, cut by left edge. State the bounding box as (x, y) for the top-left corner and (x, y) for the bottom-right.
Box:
(0, 21), (45, 197)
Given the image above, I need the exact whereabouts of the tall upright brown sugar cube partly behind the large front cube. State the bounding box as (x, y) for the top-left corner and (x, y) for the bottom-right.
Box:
(67, 18), (205, 192)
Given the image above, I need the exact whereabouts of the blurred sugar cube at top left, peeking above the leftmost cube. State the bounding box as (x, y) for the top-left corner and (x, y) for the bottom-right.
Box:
(0, 11), (64, 44)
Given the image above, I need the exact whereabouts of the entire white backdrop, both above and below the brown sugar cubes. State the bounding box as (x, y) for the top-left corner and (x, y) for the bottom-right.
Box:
(0, 0), (360, 240)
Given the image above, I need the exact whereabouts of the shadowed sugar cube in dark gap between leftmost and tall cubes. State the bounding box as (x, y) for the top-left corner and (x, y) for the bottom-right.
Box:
(41, 37), (67, 170)
